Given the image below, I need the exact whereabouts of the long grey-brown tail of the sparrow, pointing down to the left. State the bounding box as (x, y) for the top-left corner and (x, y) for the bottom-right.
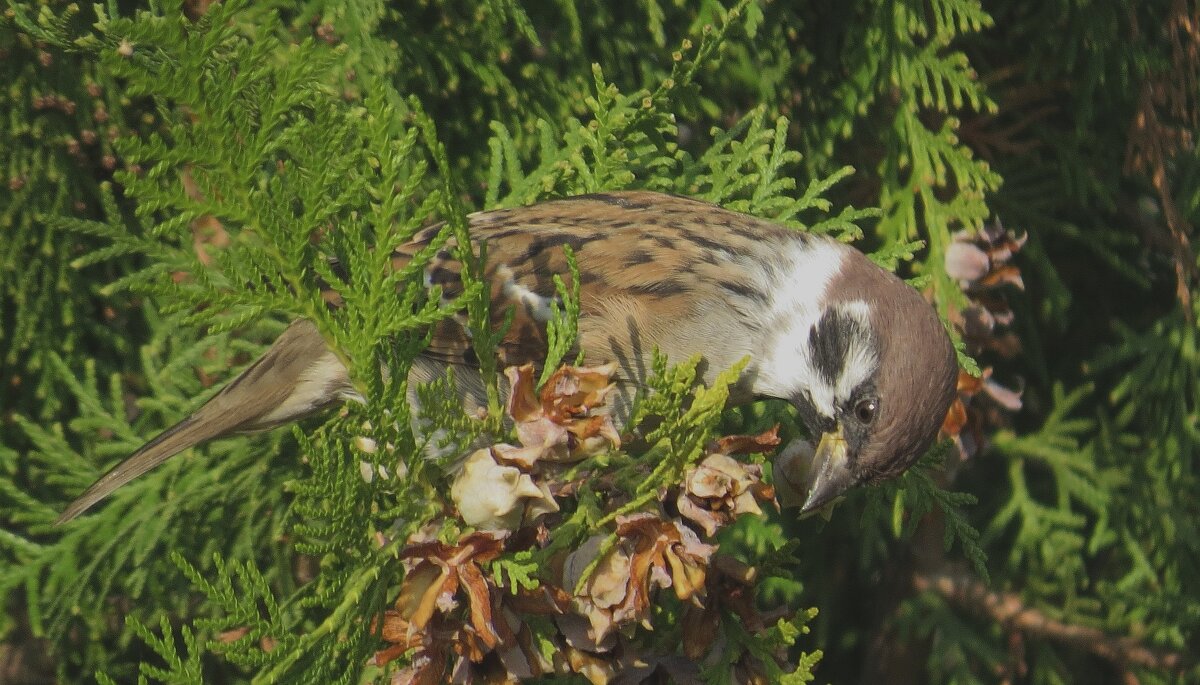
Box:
(58, 319), (358, 523)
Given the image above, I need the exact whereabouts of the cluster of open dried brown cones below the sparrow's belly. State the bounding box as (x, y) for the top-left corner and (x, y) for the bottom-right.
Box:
(388, 366), (801, 685)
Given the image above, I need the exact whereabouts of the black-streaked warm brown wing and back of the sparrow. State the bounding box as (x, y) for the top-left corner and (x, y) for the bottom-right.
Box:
(392, 192), (734, 380)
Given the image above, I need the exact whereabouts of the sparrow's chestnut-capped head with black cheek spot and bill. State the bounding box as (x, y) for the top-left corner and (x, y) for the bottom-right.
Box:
(758, 241), (958, 513)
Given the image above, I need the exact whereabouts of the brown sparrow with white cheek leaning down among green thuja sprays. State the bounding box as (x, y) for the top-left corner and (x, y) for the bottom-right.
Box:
(59, 191), (958, 523)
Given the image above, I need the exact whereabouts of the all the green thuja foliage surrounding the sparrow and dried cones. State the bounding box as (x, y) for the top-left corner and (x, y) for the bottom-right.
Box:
(0, 0), (1200, 683)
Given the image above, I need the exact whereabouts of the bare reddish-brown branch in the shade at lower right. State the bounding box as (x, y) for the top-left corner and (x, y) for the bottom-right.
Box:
(913, 573), (1192, 673)
